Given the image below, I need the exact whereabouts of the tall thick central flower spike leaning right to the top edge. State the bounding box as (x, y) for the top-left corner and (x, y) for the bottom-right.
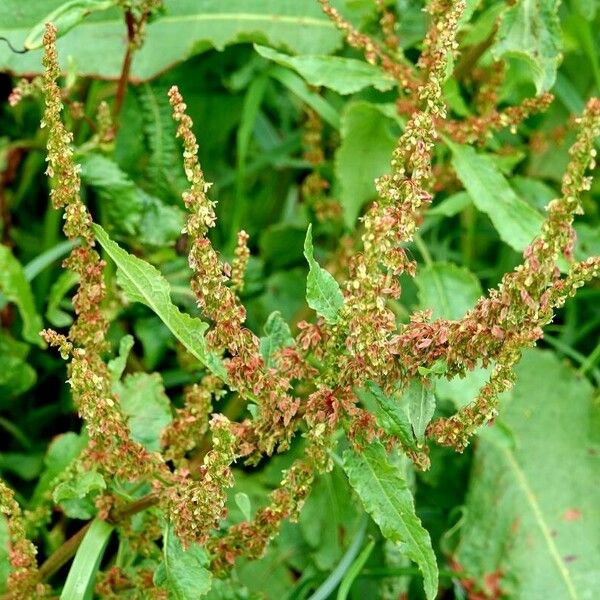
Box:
(318, 2), (464, 386)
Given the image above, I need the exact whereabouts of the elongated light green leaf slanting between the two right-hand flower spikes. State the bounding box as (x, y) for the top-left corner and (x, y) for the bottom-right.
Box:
(448, 142), (543, 252)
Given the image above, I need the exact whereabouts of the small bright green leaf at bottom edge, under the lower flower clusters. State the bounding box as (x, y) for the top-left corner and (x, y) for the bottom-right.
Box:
(154, 526), (212, 600)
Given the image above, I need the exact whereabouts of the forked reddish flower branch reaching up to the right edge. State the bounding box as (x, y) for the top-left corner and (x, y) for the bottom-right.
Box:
(422, 98), (600, 450)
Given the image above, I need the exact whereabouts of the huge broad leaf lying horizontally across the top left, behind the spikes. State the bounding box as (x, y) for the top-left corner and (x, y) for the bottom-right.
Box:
(0, 0), (342, 80)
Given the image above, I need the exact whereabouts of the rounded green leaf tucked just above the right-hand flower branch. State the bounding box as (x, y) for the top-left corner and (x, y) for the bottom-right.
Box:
(415, 263), (483, 320)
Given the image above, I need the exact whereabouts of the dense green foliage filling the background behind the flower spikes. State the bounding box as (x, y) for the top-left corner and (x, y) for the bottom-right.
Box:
(0, 0), (600, 600)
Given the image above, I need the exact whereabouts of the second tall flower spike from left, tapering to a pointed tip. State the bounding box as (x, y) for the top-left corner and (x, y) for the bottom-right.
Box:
(169, 86), (300, 454)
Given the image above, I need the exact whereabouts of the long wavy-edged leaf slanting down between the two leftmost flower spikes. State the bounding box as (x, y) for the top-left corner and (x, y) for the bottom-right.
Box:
(94, 225), (227, 381)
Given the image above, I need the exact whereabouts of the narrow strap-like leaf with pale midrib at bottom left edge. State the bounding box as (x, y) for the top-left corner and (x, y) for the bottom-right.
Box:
(60, 519), (114, 600)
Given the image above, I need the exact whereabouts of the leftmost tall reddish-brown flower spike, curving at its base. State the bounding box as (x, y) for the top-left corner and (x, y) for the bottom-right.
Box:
(42, 24), (166, 488)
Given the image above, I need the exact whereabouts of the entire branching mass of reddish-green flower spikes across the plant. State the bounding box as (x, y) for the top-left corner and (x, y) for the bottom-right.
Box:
(0, 0), (600, 598)
